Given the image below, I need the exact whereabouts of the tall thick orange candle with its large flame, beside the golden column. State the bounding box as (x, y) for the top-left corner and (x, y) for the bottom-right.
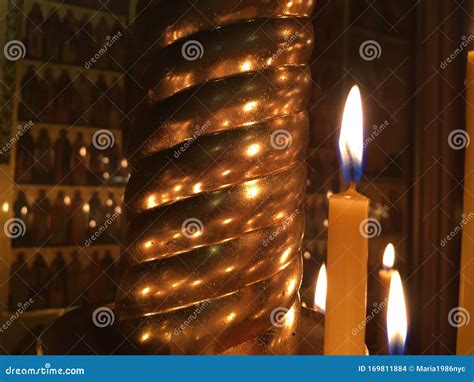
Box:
(324, 86), (369, 355)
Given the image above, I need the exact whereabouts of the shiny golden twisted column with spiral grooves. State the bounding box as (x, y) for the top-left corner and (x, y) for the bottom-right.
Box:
(116, 0), (314, 354)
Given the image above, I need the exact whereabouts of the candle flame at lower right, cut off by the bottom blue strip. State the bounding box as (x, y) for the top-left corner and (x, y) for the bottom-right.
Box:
(387, 271), (408, 355)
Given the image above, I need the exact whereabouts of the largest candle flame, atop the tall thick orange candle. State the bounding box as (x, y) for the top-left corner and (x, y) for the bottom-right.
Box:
(339, 85), (364, 183)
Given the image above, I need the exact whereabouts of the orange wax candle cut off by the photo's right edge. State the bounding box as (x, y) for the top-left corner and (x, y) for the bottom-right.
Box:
(456, 51), (474, 355)
